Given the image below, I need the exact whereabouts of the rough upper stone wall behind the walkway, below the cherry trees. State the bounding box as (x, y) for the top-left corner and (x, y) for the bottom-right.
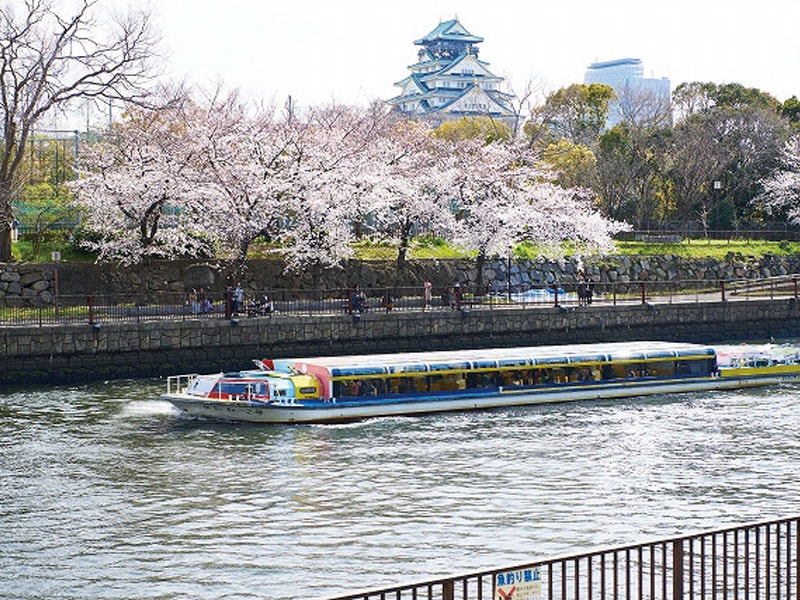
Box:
(0, 254), (800, 307)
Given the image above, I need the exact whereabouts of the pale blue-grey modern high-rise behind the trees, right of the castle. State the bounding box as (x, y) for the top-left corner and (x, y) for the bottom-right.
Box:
(583, 58), (672, 128)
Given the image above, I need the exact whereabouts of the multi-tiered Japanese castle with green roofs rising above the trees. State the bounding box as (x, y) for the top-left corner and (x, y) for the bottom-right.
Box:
(387, 18), (516, 121)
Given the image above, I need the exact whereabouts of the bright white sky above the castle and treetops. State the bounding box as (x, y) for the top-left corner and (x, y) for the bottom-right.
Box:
(141, 0), (800, 105)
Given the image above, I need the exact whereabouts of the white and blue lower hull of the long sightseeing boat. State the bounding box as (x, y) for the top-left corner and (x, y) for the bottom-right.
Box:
(162, 374), (780, 423)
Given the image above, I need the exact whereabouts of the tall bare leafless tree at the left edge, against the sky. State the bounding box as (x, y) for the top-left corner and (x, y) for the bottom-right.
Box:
(0, 0), (157, 262)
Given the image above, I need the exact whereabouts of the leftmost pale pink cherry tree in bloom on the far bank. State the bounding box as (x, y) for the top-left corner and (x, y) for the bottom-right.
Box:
(73, 95), (212, 264)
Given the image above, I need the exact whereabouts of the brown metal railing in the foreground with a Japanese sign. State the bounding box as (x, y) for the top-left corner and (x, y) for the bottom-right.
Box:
(328, 517), (800, 600)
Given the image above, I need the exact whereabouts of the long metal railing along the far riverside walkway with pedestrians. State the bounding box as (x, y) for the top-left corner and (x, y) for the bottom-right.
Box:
(0, 276), (800, 326)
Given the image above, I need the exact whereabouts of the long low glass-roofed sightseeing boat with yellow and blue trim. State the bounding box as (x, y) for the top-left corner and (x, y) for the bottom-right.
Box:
(162, 342), (800, 423)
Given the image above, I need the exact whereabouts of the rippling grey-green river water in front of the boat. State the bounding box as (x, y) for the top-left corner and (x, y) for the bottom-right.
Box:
(0, 370), (800, 599)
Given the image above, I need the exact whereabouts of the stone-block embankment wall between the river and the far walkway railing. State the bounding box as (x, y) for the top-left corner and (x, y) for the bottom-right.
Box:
(0, 298), (800, 386)
